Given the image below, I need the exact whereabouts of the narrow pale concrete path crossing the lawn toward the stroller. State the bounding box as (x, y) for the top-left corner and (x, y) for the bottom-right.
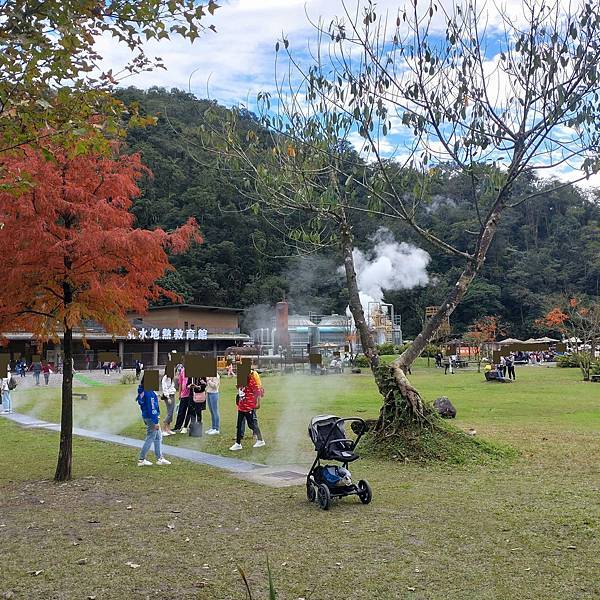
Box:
(0, 413), (306, 487)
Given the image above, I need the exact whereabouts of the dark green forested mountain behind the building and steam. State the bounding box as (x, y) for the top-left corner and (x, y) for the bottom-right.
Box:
(119, 88), (600, 336)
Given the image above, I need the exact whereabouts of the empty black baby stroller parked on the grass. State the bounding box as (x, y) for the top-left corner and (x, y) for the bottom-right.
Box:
(306, 415), (373, 510)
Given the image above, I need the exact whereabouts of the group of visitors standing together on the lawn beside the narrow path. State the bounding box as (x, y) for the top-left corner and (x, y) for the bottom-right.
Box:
(136, 354), (265, 467)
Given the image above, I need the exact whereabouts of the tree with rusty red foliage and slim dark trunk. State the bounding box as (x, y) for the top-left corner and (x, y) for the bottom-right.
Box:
(0, 147), (201, 481)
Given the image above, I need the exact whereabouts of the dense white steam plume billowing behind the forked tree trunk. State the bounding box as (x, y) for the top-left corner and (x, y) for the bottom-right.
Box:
(342, 227), (431, 312)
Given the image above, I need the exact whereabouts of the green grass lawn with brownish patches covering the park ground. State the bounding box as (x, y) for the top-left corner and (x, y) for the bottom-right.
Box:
(0, 363), (600, 600)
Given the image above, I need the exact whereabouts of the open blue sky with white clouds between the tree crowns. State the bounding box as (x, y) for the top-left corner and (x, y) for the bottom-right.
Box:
(98, 0), (600, 186)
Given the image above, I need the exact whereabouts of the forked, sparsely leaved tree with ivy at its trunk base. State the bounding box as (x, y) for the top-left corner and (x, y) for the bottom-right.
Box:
(196, 0), (600, 446)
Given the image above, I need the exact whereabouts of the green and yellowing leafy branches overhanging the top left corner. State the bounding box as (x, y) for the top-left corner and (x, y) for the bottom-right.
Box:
(0, 0), (218, 152)
